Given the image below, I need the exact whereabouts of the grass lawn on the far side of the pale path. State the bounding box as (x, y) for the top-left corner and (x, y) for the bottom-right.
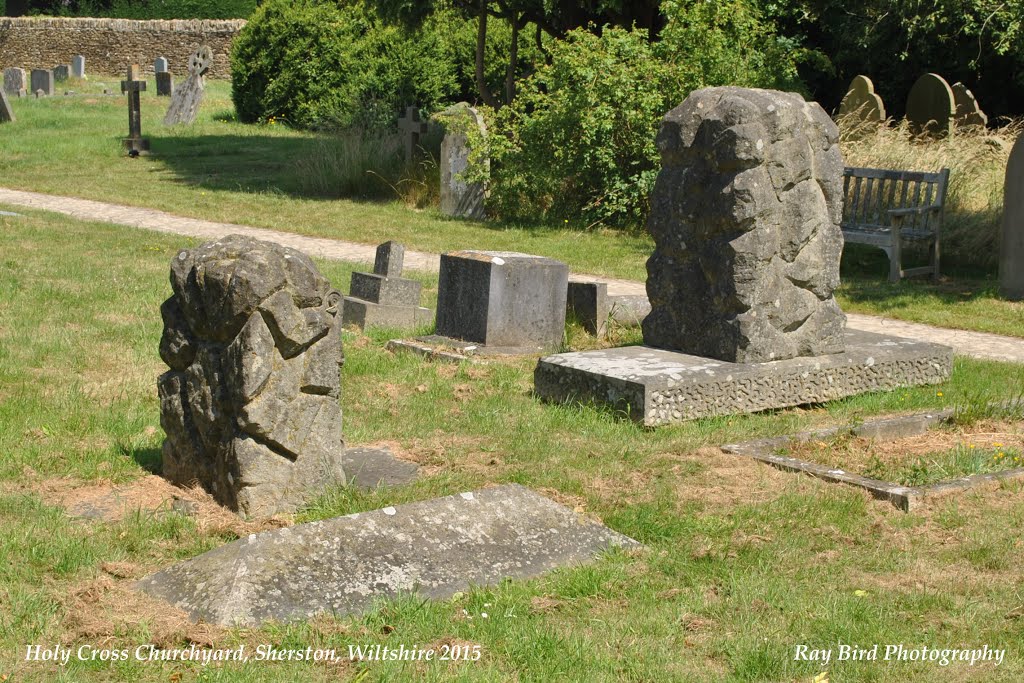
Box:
(0, 77), (1024, 337)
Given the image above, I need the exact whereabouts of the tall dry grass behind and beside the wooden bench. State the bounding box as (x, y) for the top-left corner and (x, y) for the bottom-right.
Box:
(840, 121), (1024, 269)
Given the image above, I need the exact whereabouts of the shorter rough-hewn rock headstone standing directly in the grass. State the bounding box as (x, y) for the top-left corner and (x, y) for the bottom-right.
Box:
(158, 234), (345, 516)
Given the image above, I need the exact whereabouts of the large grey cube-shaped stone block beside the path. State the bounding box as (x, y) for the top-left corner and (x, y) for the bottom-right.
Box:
(436, 251), (568, 349)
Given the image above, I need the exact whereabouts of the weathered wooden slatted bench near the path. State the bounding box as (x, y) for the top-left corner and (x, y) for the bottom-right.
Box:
(842, 167), (949, 283)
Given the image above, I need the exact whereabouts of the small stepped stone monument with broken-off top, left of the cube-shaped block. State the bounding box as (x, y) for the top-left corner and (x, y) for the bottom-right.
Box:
(342, 242), (431, 330)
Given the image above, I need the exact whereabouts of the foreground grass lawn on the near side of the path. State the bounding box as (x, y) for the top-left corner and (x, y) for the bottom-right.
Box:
(0, 205), (1024, 682)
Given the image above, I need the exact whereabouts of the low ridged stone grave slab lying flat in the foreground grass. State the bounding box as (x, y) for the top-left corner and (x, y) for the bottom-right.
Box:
(136, 484), (639, 626)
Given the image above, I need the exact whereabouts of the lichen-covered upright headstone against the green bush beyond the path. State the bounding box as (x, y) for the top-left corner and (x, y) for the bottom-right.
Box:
(437, 102), (490, 220)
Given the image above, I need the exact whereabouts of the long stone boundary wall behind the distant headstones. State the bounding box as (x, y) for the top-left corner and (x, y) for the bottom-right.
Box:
(0, 16), (246, 79)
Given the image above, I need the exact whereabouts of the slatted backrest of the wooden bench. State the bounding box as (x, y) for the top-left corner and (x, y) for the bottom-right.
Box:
(843, 167), (949, 231)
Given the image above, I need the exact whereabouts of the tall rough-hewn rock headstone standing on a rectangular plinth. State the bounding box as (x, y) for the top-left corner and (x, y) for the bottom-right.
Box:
(643, 87), (846, 362)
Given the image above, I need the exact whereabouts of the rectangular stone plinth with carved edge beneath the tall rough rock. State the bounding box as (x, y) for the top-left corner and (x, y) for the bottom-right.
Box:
(534, 331), (953, 426)
